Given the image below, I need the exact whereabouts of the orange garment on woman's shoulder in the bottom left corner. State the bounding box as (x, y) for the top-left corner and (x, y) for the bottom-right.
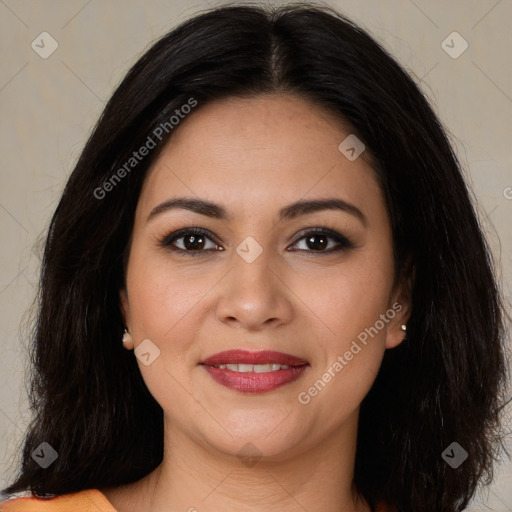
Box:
(0, 489), (117, 512)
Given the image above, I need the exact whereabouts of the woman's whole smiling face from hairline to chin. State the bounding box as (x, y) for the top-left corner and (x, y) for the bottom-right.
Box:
(121, 94), (408, 458)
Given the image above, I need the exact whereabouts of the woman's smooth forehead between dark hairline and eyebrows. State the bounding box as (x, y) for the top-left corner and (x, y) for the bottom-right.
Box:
(136, 94), (382, 220)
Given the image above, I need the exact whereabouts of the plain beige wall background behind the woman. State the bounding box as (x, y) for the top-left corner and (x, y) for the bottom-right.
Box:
(0, 0), (512, 512)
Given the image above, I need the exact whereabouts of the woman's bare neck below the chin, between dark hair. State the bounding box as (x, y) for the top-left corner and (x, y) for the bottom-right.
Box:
(105, 408), (370, 512)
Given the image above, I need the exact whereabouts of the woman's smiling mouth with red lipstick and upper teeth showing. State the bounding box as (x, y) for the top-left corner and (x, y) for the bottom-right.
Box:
(201, 350), (309, 393)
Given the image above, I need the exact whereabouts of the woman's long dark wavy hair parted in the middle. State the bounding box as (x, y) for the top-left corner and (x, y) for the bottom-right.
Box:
(3, 4), (507, 512)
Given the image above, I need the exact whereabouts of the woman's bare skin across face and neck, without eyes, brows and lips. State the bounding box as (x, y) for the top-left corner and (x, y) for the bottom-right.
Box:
(102, 93), (410, 512)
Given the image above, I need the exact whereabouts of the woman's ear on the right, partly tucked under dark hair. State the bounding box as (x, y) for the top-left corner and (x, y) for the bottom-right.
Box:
(386, 258), (416, 348)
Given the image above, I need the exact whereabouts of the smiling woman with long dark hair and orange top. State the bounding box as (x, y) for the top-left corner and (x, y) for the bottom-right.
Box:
(2, 6), (505, 512)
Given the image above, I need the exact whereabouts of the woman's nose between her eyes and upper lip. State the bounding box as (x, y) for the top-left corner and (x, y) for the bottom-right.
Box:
(216, 251), (293, 332)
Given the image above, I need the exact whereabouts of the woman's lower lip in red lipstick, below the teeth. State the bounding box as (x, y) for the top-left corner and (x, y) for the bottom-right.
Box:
(203, 364), (309, 393)
